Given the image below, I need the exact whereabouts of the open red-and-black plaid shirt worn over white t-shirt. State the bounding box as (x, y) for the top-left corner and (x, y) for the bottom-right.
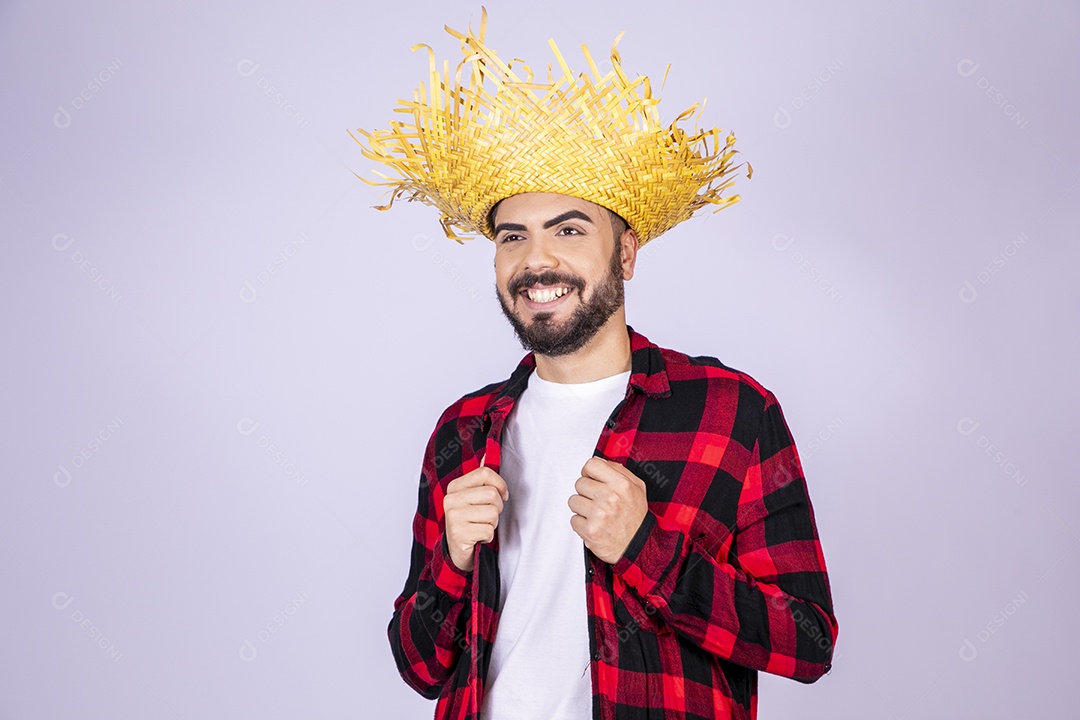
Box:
(388, 325), (837, 720)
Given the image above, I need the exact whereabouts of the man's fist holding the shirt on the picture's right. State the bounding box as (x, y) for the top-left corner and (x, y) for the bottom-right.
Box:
(567, 456), (649, 565)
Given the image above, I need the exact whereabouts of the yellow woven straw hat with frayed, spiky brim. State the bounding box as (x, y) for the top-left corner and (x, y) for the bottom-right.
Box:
(350, 10), (753, 245)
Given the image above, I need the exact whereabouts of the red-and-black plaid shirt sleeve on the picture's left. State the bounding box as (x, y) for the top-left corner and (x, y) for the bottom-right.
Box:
(387, 423), (472, 699)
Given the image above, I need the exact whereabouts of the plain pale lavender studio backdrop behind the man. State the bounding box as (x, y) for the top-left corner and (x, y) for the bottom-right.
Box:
(0, 0), (1080, 720)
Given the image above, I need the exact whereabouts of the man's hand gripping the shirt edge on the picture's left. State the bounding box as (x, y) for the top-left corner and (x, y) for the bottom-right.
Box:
(443, 457), (510, 572)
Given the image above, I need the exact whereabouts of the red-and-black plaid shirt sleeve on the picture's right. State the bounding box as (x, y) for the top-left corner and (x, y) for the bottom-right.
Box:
(612, 393), (838, 682)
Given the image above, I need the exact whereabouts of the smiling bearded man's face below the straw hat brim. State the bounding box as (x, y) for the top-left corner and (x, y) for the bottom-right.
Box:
(495, 192), (637, 356)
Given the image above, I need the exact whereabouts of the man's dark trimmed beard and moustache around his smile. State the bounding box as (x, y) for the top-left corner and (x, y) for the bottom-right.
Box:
(495, 242), (623, 357)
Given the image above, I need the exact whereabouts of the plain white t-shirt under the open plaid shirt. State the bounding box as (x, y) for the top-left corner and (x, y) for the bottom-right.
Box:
(481, 370), (630, 720)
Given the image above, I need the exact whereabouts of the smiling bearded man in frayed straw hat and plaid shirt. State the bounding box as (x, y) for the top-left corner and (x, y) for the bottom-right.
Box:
(354, 11), (837, 720)
